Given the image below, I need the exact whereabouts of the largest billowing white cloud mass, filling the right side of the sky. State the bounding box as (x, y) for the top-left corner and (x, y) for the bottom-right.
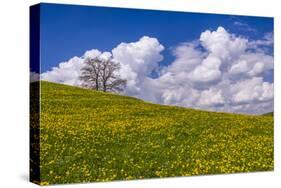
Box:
(148, 27), (273, 114)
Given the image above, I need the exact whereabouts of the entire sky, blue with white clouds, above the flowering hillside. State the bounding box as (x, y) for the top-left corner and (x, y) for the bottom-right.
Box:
(31, 4), (274, 114)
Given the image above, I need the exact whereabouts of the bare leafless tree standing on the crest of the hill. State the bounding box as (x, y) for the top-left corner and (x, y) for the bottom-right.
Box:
(80, 57), (126, 92)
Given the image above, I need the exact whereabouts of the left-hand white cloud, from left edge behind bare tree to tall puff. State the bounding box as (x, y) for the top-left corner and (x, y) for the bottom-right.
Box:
(41, 36), (164, 91)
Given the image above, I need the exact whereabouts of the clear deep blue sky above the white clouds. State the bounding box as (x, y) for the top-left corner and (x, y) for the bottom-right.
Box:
(38, 4), (273, 72)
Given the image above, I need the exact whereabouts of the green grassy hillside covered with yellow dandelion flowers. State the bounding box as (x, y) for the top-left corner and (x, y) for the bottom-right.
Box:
(34, 82), (273, 184)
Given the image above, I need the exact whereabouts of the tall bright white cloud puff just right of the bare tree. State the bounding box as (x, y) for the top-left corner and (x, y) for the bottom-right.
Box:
(112, 36), (164, 96)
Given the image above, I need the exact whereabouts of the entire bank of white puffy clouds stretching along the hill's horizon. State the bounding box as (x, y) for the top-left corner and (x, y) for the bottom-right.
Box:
(41, 27), (273, 114)
